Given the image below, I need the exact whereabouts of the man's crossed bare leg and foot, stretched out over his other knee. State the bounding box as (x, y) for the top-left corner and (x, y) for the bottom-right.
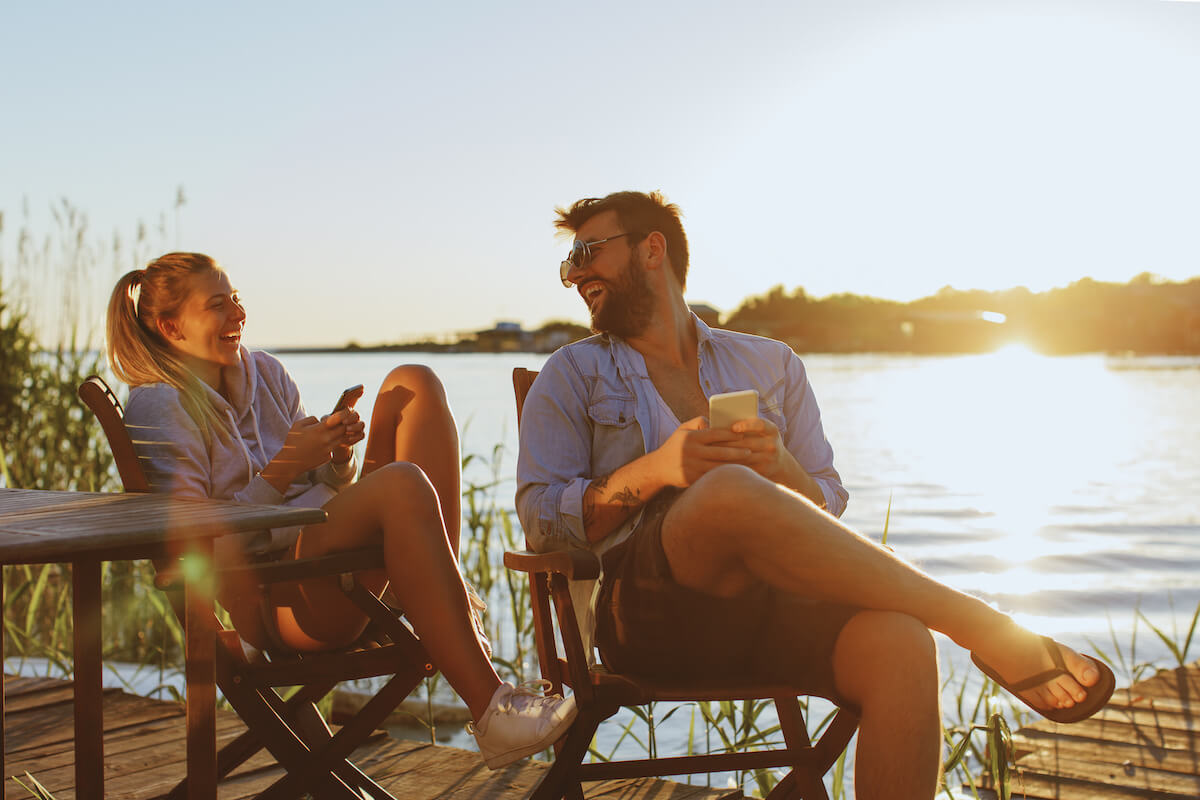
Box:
(662, 465), (1099, 709)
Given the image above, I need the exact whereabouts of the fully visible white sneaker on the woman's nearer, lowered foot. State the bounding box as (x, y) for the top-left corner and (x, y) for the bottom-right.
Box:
(467, 680), (578, 770)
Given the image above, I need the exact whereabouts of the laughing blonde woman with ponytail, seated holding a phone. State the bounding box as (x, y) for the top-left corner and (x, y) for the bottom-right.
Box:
(108, 253), (576, 769)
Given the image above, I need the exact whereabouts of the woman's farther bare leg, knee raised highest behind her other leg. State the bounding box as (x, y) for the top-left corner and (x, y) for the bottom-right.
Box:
(362, 365), (462, 555)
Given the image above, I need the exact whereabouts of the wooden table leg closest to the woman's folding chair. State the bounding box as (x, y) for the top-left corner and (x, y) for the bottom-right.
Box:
(184, 539), (217, 800)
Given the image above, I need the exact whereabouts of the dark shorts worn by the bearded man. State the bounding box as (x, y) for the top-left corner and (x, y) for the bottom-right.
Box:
(596, 489), (859, 700)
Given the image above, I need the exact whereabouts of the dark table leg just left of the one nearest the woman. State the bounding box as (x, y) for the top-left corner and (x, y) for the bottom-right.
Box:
(71, 559), (104, 800)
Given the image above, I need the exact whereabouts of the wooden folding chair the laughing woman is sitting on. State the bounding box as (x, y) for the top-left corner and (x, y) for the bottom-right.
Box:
(79, 375), (436, 800)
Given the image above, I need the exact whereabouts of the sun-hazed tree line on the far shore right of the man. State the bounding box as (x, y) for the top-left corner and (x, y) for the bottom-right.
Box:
(724, 272), (1200, 354)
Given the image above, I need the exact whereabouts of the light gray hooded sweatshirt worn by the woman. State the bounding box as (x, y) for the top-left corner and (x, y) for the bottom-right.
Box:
(125, 348), (355, 552)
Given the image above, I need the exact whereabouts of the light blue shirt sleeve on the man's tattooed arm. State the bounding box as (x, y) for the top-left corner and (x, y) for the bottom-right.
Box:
(516, 351), (592, 551)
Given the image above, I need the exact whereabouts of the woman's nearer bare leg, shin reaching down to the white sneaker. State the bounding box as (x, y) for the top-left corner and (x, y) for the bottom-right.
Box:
(280, 463), (500, 720)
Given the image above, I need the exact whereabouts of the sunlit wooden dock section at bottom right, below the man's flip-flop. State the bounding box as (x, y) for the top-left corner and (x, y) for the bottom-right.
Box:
(980, 661), (1200, 800)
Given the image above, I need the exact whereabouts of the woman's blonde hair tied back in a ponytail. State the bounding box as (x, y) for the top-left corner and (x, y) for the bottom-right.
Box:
(107, 253), (221, 429)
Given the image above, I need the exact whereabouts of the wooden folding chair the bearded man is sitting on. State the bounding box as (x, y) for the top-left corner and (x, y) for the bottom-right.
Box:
(504, 368), (858, 800)
